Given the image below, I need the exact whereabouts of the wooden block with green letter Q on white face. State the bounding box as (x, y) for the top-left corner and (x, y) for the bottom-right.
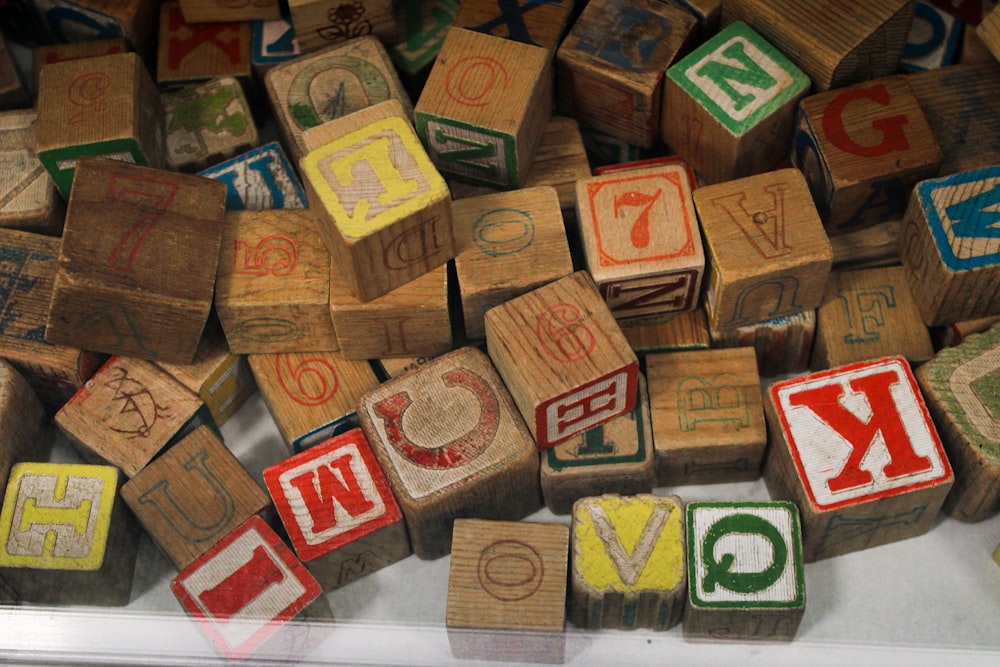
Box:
(684, 502), (806, 641)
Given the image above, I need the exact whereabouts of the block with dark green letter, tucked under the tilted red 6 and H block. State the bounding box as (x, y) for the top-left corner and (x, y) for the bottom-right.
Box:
(539, 375), (656, 514)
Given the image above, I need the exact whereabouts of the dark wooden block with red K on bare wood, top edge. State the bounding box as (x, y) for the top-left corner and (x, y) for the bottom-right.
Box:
(156, 0), (252, 91)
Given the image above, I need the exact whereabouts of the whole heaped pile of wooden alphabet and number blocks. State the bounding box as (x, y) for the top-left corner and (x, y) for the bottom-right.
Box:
(0, 0), (1000, 657)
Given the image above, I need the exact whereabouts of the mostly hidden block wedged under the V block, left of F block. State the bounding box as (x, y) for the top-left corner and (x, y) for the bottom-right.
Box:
(709, 310), (816, 377)
